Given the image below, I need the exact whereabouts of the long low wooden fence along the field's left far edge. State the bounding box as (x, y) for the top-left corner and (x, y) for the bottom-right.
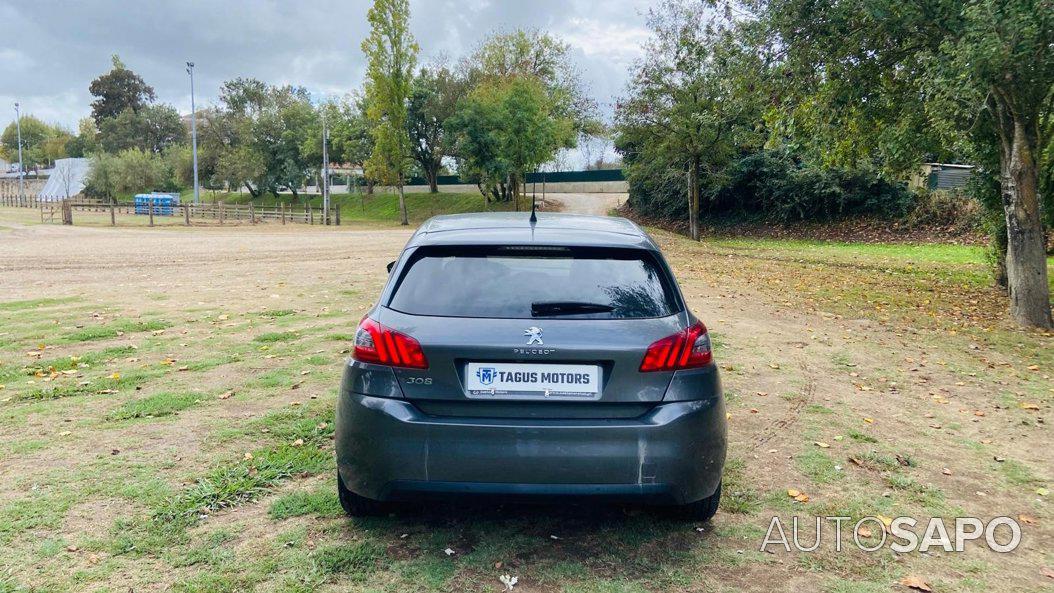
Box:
(0, 196), (340, 226)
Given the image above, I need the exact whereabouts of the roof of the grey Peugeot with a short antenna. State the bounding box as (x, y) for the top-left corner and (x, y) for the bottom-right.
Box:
(407, 212), (659, 251)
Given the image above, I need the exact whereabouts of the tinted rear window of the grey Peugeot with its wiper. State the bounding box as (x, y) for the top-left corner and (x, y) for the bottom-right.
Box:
(388, 246), (679, 319)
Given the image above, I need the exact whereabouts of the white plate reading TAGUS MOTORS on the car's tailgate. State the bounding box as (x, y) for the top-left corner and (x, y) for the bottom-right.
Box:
(465, 362), (600, 397)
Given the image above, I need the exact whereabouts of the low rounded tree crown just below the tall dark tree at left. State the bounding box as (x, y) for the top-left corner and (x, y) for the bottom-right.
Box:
(98, 105), (188, 154)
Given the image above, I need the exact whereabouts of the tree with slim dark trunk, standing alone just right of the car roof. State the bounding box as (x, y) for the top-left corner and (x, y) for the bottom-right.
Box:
(617, 0), (761, 240)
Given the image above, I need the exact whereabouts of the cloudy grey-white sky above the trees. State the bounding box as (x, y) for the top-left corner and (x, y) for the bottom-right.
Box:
(0, 0), (647, 136)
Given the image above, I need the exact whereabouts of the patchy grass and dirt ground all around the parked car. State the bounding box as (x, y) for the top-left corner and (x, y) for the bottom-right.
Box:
(0, 206), (1054, 593)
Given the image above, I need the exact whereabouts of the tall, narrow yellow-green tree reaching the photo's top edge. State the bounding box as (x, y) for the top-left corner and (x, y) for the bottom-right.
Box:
(363, 0), (418, 224)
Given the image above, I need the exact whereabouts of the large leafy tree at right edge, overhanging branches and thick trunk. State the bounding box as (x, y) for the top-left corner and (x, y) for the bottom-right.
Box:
(758, 0), (1054, 328)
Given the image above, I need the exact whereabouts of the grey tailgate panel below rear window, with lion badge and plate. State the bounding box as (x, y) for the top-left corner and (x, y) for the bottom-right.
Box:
(375, 308), (685, 403)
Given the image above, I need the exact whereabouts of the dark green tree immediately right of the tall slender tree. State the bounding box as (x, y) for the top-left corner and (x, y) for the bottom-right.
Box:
(407, 66), (466, 194)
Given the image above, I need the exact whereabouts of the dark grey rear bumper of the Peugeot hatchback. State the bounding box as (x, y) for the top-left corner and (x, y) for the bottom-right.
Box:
(336, 392), (726, 503)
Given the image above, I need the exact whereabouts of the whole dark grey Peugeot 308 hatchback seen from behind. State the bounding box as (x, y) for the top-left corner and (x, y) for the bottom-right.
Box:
(336, 213), (726, 520)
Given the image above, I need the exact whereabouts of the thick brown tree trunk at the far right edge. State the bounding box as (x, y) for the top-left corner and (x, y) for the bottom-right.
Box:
(1000, 117), (1051, 328)
